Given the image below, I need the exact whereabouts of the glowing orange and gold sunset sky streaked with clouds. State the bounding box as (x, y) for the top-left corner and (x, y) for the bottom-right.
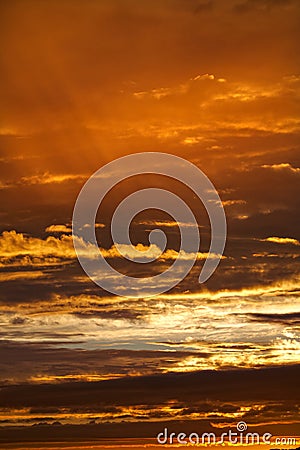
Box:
(0, 0), (300, 449)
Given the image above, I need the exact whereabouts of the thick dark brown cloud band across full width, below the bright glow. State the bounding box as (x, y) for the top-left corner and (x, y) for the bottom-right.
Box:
(0, 366), (299, 407)
